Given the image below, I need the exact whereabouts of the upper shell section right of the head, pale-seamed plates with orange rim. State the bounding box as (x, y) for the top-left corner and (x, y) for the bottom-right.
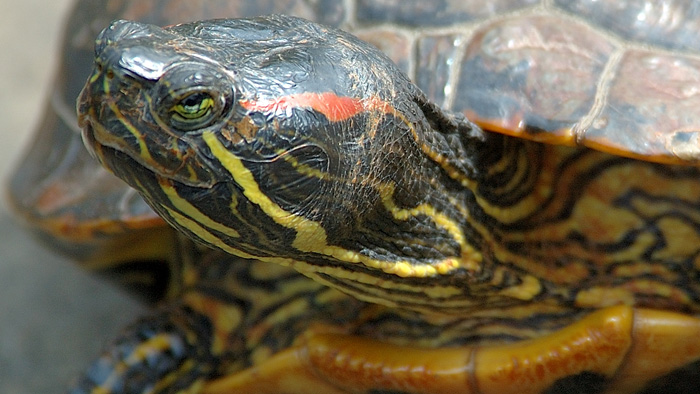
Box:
(356, 0), (700, 165)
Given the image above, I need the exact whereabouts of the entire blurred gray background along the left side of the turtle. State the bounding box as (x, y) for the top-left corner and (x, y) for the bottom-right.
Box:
(0, 0), (143, 394)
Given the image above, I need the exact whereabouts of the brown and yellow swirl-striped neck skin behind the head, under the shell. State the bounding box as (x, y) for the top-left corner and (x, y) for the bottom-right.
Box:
(417, 114), (700, 316)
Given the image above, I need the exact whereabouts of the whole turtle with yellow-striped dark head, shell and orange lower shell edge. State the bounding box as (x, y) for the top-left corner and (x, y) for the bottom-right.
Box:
(11, 0), (700, 393)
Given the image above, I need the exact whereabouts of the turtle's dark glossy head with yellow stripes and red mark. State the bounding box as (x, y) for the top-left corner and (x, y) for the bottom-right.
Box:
(78, 16), (490, 310)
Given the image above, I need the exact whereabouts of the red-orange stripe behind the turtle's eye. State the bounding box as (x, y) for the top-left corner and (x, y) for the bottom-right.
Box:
(241, 92), (394, 122)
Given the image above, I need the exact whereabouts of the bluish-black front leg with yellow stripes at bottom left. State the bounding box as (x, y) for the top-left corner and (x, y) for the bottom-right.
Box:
(69, 305), (218, 394)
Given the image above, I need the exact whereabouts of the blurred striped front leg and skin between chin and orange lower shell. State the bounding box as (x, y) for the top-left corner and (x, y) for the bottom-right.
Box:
(72, 239), (592, 393)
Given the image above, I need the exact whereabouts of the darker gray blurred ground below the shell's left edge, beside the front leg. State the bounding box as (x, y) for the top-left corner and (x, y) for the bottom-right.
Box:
(0, 214), (142, 393)
